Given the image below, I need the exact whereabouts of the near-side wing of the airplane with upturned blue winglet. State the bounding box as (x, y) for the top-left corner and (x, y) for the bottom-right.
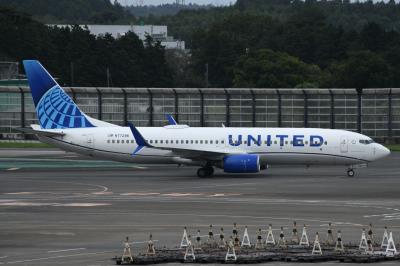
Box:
(128, 123), (244, 160)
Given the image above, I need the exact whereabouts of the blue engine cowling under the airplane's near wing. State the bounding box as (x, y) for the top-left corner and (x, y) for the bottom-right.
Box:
(224, 154), (260, 173)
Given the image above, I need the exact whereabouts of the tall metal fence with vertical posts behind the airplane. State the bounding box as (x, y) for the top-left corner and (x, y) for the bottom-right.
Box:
(0, 87), (400, 142)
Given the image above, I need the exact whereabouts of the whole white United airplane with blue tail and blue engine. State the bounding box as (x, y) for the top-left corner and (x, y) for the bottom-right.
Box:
(23, 60), (390, 177)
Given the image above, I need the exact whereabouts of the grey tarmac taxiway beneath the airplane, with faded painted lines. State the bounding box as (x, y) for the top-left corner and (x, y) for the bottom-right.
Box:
(0, 149), (400, 265)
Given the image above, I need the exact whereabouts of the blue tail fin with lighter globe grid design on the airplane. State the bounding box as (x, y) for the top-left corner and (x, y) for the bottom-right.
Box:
(23, 60), (94, 129)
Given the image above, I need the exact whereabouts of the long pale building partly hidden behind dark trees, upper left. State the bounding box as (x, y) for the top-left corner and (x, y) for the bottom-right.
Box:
(48, 25), (185, 50)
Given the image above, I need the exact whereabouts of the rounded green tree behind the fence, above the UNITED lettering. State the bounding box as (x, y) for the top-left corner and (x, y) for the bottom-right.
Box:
(234, 49), (320, 88)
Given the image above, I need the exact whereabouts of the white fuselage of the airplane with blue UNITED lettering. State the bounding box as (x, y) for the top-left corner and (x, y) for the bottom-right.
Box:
(39, 125), (389, 166)
